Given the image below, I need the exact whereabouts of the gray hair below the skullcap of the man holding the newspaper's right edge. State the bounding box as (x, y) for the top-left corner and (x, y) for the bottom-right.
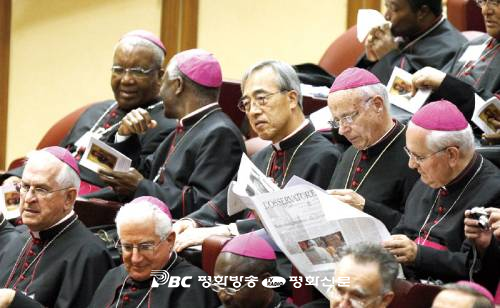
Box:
(409, 121), (474, 154)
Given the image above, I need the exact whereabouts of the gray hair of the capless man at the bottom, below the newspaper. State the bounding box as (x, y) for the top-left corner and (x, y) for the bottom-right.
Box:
(339, 242), (399, 293)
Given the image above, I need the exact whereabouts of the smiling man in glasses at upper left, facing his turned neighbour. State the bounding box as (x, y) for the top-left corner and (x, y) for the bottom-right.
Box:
(3, 30), (176, 194)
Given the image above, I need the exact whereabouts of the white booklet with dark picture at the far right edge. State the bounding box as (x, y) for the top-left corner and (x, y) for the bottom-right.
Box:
(472, 94), (500, 134)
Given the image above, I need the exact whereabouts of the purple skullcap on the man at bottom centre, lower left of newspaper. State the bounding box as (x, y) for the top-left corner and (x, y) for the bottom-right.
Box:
(221, 232), (276, 260)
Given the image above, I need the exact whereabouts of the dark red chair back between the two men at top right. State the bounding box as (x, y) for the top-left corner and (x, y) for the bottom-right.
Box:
(446, 0), (486, 32)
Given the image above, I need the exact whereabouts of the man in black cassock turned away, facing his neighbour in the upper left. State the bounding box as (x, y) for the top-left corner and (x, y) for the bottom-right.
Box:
(87, 50), (248, 218)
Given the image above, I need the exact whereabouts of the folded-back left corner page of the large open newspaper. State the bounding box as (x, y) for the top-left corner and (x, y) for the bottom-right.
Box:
(227, 153), (279, 216)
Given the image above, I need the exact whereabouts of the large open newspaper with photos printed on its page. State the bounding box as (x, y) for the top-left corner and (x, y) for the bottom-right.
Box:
(228, 158), (390, 297)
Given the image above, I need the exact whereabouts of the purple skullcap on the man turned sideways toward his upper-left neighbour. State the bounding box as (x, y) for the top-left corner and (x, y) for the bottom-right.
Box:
(175, 49), (222, 88)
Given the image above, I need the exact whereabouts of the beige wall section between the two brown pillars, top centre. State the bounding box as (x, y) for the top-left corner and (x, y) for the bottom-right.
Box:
(198, 0), (347, 79)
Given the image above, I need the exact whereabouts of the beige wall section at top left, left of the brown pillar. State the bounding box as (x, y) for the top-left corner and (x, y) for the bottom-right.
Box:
(6, 0), (161, 162)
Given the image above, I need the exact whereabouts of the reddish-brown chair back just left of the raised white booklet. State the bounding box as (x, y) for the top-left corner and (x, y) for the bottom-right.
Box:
(318, 26), (364, 76)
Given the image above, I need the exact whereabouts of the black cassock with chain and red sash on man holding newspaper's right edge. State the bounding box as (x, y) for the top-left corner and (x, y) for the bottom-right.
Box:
(392, 154), (500, 282)
